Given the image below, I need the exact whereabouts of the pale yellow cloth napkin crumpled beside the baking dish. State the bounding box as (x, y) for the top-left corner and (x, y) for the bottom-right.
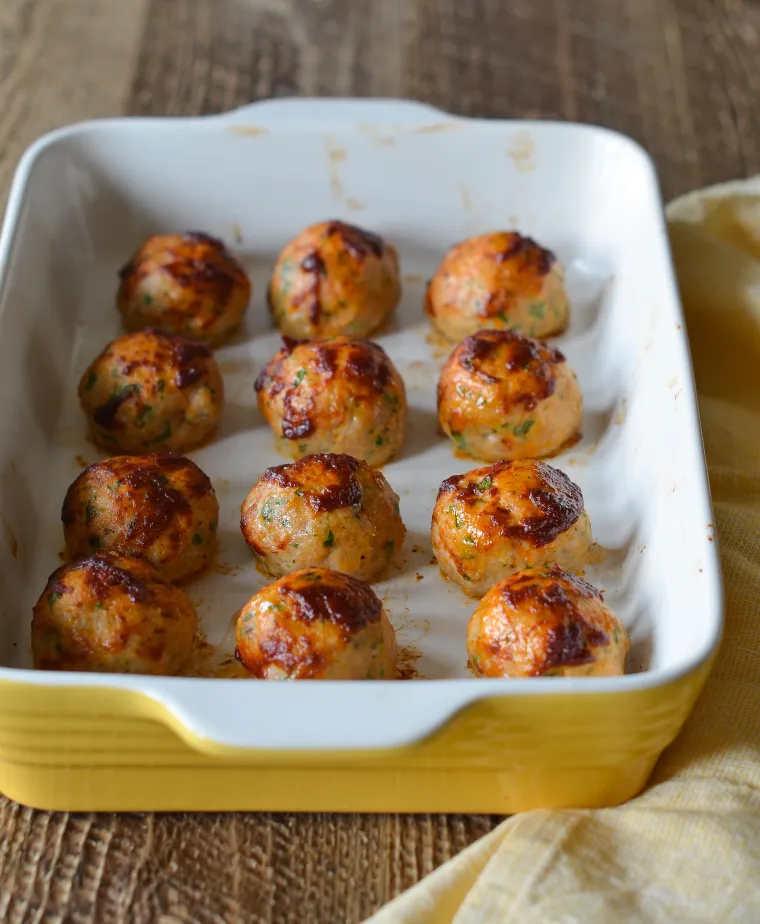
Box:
(370, 177), (760, 924)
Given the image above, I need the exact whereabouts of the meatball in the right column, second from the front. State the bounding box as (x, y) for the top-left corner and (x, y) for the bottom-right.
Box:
(431, 459), (592, 597)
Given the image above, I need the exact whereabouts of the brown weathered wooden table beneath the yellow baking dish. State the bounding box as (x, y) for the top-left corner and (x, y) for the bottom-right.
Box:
(0, 0), (760, 924)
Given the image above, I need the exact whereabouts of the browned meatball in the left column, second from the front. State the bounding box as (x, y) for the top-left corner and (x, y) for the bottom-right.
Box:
(61, 453), (219, 581)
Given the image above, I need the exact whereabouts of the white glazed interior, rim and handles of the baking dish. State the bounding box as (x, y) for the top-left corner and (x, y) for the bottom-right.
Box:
(0, 100), (721, 748)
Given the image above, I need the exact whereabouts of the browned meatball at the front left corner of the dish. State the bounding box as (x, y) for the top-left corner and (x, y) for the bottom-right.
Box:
(32, 554), (198, 674)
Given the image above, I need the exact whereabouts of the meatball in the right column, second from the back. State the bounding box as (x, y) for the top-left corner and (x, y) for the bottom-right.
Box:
(438, 330), (583, 462)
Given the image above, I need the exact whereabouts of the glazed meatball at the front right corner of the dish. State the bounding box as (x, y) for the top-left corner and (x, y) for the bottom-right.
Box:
(467, 565), (631, 677)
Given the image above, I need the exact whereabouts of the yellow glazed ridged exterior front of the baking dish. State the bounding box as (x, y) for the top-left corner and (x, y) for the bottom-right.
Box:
(0, 662), (711, 814)
